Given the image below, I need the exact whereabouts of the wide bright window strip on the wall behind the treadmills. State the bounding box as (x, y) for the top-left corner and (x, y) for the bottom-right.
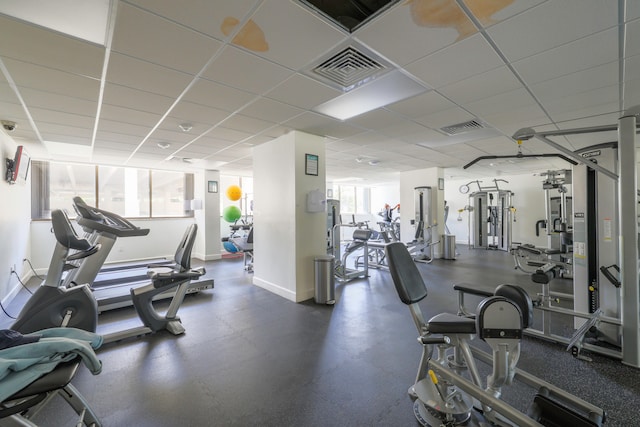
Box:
(31, 161), (193, 219)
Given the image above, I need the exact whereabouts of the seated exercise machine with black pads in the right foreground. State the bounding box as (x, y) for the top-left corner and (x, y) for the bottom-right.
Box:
(386, 243), (605, 427)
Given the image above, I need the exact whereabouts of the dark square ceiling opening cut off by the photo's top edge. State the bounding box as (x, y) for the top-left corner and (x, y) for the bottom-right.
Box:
(298, 0), (400, 33)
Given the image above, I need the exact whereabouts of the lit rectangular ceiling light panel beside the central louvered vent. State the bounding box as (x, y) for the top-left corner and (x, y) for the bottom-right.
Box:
(313, 70), (429, 120)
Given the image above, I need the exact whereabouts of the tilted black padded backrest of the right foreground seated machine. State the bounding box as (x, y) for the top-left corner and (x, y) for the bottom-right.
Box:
(384, 242), (427, 305)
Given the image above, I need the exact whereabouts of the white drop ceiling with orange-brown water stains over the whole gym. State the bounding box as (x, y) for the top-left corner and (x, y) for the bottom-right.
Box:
(0, 0), (640, 185)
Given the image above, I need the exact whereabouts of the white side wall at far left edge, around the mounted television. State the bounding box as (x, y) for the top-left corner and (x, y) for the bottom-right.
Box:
(0, 130), (31, 304)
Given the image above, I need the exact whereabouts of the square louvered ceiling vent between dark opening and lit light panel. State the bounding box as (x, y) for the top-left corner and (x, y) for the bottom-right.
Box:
(306, 43), (393, 92)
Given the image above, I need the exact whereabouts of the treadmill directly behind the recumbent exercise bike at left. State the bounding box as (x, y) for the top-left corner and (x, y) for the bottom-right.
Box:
(63, 197), (214, 312)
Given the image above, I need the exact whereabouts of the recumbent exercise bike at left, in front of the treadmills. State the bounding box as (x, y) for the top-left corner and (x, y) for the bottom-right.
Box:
(12, 210), (205, 343)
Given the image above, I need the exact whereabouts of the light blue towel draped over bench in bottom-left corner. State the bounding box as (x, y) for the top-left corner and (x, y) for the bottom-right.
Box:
(0, 328), (102, 402)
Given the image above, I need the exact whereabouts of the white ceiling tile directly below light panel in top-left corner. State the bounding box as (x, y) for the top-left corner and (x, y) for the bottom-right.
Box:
(0, 15), (105, 78)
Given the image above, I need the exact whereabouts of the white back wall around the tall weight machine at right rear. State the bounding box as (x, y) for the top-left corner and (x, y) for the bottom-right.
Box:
(444, 174), (547, 247)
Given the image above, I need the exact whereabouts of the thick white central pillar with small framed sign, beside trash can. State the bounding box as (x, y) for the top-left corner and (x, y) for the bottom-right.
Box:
(253, 132), (326, 302)
